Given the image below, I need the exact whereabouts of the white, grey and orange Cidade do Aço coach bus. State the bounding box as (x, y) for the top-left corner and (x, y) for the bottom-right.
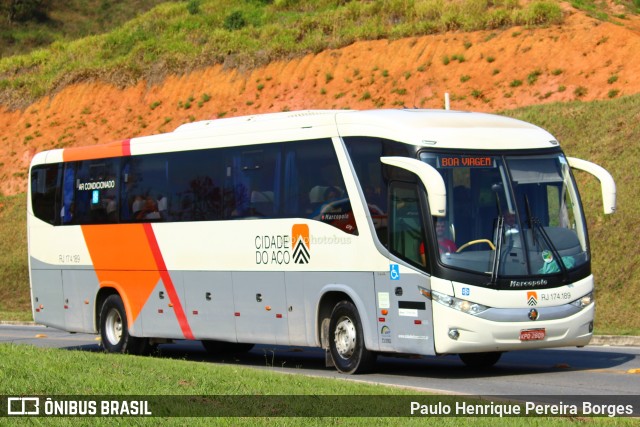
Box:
(27, 110), (615, 373)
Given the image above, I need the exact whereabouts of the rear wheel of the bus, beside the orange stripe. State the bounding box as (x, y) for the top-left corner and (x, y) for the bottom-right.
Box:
(100, 294), (152, 354)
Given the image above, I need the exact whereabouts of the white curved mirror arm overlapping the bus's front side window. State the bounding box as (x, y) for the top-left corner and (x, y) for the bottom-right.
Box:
(380, 156), (447, 217)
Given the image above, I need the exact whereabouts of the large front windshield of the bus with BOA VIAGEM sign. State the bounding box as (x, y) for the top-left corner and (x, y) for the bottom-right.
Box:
(420, 153), (589, 282)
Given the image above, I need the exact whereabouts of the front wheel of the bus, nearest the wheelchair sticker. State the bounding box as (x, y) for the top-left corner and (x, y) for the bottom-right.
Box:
(329, 301), (376, 374)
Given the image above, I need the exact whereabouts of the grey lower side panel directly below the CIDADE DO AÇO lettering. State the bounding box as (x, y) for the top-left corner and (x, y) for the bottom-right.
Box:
(232, 271), (289, 345)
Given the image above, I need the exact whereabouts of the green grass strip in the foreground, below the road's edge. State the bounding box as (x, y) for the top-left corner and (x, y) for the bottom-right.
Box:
(0, 344), (635, 427)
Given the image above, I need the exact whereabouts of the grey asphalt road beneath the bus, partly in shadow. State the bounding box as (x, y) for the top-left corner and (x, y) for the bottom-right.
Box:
(0, 325), (640, 400)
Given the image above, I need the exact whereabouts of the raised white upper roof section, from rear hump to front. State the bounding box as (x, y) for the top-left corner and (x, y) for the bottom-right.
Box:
(175, 109), (558, 150)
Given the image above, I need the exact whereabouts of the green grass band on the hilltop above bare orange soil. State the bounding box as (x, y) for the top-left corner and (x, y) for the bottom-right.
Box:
(0, 0), (563, 107)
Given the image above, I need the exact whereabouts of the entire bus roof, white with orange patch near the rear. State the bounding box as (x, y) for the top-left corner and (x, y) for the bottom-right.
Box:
(32, 109), (558, 164)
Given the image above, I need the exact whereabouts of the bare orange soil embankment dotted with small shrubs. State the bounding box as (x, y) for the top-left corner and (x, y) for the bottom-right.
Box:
(0, 6), (640, 195)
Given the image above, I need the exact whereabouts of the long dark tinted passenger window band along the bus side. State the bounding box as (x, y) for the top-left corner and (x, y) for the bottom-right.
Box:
(34, 139), (357, 234)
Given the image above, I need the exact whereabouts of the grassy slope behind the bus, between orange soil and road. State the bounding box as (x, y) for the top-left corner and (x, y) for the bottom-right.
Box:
(0, 95), (640, 335)
